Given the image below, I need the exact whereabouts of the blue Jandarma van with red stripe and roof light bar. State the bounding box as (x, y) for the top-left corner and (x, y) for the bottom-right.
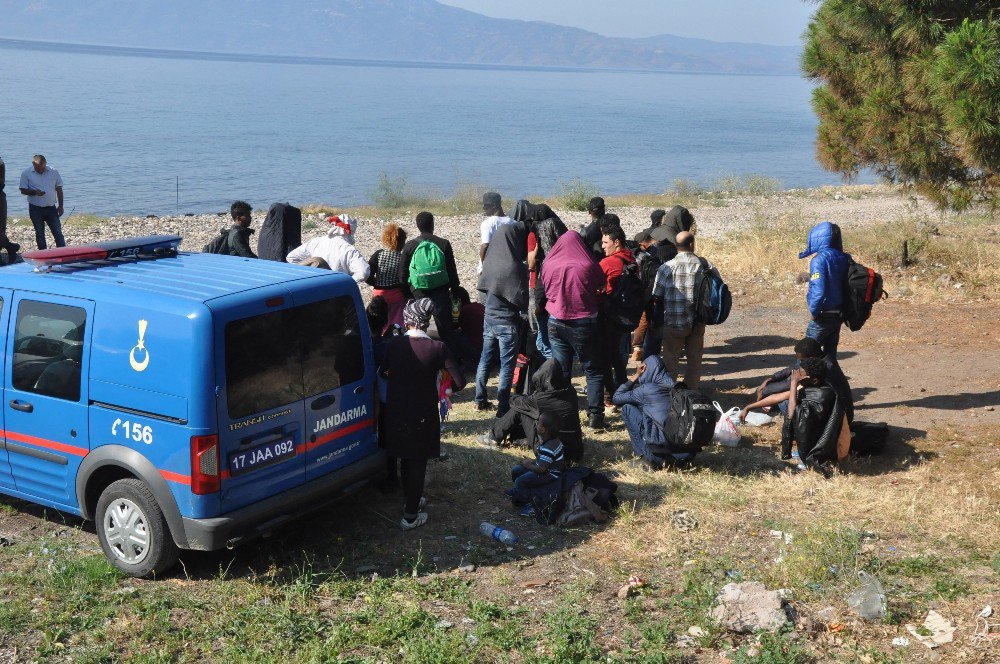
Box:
(0, 236), (385, 577)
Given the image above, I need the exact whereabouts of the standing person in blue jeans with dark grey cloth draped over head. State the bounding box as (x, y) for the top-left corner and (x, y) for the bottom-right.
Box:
(476, 224), (528, 415)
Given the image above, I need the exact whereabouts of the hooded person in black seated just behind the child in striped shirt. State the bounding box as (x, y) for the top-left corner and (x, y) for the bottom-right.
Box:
(479, 359), (583, 462)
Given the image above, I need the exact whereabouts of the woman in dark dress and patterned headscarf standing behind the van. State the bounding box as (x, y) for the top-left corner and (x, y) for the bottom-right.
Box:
(379, 298), (465, 530)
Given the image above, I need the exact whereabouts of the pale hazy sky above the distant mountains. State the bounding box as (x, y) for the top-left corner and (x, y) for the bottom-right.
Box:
(440, 0), (816, 45)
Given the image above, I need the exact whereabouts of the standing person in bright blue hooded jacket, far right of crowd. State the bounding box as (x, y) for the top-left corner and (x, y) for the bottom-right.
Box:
(799, 221), (848, 362)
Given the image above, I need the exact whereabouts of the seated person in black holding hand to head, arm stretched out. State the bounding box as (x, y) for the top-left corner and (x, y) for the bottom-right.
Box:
(740, 357), (849, 477)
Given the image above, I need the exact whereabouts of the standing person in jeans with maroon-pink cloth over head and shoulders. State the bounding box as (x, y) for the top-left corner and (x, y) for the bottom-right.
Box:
(539, 231), (606, 429)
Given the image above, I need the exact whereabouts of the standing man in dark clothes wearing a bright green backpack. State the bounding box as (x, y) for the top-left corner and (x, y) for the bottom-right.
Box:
(399, 212), (479, 362)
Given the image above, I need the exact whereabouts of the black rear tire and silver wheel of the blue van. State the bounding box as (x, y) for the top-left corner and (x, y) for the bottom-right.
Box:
(95, 478), (179, 578)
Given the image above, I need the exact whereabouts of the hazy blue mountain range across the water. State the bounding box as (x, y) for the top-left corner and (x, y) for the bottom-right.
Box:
(0, 0), (799, 74)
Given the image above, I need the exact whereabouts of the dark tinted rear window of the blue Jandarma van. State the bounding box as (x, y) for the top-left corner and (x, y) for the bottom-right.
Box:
(226, 297), (365, 419)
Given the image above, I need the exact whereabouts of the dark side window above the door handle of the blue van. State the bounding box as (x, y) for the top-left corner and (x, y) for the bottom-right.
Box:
(11, 300), (87, 401)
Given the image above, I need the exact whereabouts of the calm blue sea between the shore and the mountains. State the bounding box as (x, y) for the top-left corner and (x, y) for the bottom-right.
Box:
(0, 46), (852, 215)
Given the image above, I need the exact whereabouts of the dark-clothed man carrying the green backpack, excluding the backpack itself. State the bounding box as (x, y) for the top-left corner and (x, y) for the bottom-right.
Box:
(399, 212), (479, 362)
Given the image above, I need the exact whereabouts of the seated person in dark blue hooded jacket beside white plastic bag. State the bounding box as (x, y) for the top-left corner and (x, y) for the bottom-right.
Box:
(611, 355), (695, 470)
